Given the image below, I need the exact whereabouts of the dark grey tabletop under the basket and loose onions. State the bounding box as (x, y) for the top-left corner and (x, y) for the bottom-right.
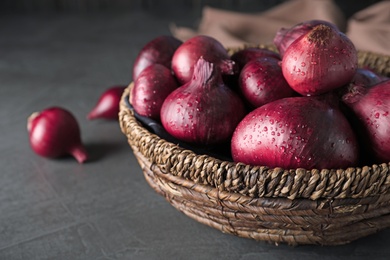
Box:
(0, 8), (390, 260)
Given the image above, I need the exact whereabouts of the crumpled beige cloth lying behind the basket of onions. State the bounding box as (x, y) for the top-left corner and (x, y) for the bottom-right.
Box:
(171, 0), (390, 55)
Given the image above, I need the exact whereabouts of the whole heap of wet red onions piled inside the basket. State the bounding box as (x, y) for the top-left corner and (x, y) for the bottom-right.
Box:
(129, 20), (390, 169)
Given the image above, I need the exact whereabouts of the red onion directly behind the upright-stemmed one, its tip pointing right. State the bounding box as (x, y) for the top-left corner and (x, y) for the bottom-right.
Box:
(172, 35), (238, 84)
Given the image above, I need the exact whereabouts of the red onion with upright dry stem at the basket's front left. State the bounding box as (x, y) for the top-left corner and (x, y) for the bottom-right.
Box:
(161, 58), (245, 145)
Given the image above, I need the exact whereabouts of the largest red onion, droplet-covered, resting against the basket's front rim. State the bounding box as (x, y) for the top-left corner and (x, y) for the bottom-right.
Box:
(231, 97), (359, 169)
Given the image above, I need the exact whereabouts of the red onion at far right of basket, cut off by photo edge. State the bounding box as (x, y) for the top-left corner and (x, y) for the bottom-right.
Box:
(343, 80), (390, 163)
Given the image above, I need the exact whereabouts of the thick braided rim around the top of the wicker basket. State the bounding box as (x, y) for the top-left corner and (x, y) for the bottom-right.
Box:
(119, 45), (390, 200)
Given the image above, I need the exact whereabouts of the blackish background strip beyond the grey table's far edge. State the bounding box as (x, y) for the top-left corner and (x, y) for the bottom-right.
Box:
(0, 0), (380, 18)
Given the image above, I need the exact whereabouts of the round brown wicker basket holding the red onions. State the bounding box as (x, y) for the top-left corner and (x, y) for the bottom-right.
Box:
(119, 46), (390, 245)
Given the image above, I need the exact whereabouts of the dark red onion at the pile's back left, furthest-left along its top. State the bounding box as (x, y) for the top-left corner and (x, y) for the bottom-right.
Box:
(133, 35), (182, 81)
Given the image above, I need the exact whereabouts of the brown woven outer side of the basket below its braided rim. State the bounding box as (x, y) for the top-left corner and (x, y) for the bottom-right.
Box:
(137, 148), (390, 245)
